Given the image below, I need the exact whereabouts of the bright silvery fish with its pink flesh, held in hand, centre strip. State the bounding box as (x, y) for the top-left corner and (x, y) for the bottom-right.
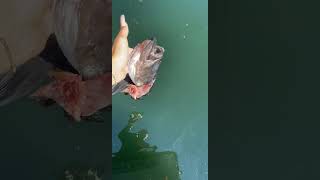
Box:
(112, 38), (165, 100)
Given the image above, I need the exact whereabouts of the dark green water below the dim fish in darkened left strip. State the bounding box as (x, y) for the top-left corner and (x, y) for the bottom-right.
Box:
(0, 99), (111, 180)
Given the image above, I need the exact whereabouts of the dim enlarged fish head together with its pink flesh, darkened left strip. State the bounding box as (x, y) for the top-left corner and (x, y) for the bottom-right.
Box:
(31, 0), (112, 121)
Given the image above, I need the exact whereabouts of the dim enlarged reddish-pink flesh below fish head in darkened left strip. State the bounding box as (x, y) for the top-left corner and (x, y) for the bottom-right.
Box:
(32, 73), (112, 121)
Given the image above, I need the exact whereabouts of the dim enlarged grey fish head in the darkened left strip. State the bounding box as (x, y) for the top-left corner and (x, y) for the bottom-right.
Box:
(53, 0), (112, 79)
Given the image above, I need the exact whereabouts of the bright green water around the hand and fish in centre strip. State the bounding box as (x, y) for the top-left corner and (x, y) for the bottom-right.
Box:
(112, 0), (208, 180)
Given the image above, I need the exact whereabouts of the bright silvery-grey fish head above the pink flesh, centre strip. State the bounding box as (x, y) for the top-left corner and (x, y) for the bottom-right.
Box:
(128, 38), (164, 86)
